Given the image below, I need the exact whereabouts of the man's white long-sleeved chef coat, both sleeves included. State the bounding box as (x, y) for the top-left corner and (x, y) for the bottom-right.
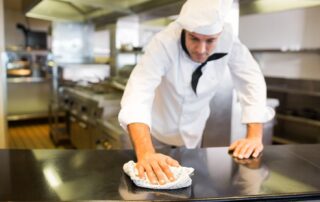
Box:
(118, 22), (274, 148)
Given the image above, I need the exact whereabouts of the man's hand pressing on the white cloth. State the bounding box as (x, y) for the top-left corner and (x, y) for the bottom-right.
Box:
(136, 152), (180, 185)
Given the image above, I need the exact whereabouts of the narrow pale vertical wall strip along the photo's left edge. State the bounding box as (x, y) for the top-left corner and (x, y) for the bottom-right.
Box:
(0, 0), (8, 148)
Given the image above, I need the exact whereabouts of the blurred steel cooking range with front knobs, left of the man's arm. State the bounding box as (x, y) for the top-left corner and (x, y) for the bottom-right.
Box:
(51, 82), (122, 149)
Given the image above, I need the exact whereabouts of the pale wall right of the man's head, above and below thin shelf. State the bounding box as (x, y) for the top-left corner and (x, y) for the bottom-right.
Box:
(239, 6), (320, 80)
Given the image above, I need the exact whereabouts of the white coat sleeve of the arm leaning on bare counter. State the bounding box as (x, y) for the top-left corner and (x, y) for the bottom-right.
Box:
(228, 37), (275, 123)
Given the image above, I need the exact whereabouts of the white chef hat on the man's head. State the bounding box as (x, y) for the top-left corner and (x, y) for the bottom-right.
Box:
(177, 0), (232, 35)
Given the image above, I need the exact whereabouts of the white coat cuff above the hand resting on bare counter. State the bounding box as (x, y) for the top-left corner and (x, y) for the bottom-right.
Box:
(241, 106), (275, 124)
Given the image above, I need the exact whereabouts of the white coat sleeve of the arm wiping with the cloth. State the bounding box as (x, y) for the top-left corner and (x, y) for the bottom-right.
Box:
(118, 37), (169, 131)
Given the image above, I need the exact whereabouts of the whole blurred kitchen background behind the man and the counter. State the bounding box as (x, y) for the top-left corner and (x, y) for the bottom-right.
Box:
(0, 0), (320, 149)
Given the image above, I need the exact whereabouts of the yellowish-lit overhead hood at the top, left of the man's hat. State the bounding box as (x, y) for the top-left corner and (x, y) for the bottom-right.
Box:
(26, 0), (185, 24)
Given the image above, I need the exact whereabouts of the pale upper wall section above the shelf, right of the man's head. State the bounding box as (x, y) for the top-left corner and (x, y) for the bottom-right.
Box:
(239, 6), (320, 50)
